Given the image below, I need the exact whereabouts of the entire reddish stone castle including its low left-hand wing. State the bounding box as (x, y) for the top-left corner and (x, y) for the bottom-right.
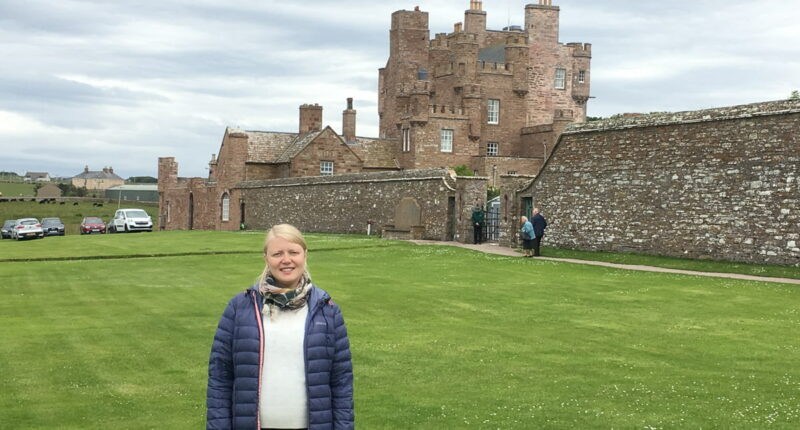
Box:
(158, 0), (591, 230)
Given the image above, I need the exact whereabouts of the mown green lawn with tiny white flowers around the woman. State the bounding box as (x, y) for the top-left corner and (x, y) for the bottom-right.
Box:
(0, 232), (800, 429)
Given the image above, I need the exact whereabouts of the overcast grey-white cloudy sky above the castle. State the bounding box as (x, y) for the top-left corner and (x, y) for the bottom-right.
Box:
(0, 0), (800, 178)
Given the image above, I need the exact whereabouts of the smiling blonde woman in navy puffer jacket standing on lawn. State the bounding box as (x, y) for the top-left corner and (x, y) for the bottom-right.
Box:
(206, 224), (354, 430)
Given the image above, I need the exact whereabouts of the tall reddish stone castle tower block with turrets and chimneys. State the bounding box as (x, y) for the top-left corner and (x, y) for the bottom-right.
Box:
(378, 0), (591, 176)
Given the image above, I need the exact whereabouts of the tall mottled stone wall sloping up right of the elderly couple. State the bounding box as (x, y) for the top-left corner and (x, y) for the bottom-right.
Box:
(514, 100), (800, 266)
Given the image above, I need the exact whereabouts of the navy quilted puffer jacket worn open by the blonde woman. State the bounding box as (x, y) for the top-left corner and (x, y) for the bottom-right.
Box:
(206, 286), (354, 430)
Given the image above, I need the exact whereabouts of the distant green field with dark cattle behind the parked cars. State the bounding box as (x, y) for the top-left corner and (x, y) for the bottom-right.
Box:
(0, 199), (158, 235)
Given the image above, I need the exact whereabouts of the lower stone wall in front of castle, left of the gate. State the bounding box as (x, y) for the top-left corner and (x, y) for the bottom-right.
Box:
(236, 169), (486, 241)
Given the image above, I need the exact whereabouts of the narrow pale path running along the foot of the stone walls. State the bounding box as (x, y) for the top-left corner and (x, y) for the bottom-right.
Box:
(411, 240), (800, 285)
